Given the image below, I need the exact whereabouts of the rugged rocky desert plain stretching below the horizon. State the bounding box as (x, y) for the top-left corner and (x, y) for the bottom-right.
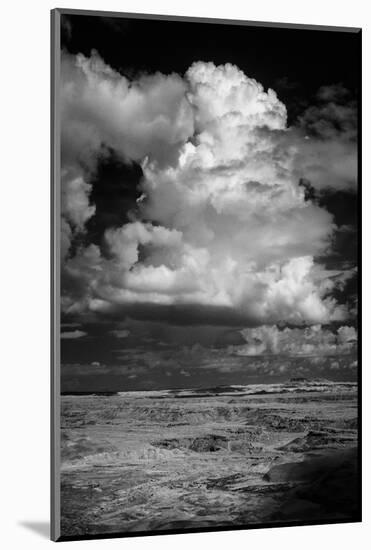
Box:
(61, 386), (359, 536)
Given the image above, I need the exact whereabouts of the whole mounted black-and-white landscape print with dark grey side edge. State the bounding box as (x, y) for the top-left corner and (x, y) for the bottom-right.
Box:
(52, 9), (361, 540)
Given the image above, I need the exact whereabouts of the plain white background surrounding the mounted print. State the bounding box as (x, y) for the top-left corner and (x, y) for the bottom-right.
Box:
(0, 0), (371, 550)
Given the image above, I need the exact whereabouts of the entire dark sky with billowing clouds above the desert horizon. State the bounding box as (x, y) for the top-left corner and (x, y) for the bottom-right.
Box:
(60, 16), (359, 390)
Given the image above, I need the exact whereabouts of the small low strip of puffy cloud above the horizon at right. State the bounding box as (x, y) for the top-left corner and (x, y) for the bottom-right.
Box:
(234, 325), (357, 356)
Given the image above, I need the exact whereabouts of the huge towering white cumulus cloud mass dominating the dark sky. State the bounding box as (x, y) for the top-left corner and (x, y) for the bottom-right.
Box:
(61, 53), (353, 323)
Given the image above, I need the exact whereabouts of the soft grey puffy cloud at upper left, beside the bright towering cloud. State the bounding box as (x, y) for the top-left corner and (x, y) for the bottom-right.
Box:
(61, 52), (193, 168)
